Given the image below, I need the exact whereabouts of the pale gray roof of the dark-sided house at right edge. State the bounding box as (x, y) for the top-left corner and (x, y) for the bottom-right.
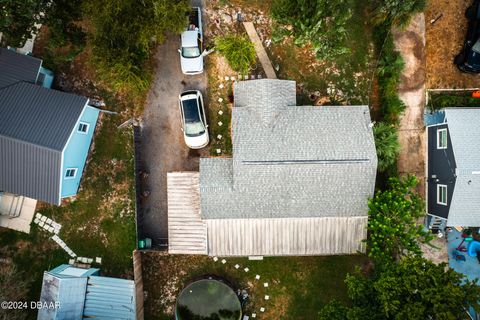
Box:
(445, 108), (480, 226)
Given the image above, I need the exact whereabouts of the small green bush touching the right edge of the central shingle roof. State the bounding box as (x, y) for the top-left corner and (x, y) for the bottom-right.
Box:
(373, 122), (400, 172)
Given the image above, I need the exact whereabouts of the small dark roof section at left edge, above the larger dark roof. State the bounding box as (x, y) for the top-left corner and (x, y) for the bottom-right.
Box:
(0, 48), (42, 88)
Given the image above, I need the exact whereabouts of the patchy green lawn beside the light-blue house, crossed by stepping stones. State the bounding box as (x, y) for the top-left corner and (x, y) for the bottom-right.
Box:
(0, 104), (135, 319)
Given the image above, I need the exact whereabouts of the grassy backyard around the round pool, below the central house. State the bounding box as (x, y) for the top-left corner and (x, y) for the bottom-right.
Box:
(142, 253), (367, 320)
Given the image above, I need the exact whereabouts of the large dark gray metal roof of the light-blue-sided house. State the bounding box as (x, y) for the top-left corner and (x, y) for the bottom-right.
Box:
(0, 82), (88, 204)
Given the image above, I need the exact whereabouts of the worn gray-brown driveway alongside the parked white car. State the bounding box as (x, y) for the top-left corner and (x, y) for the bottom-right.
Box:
(139, 2), (208, 245)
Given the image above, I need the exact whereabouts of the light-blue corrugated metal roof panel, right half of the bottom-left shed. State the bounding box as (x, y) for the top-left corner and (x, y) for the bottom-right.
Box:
(83, 276), (136, 320)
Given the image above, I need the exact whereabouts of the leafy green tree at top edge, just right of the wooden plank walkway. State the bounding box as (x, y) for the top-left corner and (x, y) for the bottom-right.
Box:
(271, 0), (352, 60)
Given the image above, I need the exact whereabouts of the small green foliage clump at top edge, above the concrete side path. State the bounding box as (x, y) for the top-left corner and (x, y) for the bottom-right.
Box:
(373, 0), (427, 27)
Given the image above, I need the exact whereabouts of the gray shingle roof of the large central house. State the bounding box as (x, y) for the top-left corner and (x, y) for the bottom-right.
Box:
(200, 79), (377, 219)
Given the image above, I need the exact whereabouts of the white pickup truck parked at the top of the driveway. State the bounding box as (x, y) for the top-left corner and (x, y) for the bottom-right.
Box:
(178, 7), (205, 74)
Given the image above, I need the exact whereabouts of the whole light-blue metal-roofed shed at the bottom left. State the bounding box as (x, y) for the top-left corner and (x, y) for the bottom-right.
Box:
(37, 264), (136, 320)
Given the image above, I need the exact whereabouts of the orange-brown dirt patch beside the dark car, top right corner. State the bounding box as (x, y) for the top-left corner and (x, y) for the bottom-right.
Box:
(425, 0), (480, 89)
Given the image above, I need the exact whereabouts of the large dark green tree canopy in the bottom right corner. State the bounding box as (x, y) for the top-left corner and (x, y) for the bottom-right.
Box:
(319, 256), (480, 320)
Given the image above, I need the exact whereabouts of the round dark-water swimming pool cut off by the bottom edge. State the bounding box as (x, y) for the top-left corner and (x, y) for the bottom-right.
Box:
(175, 279), (242, 320)
